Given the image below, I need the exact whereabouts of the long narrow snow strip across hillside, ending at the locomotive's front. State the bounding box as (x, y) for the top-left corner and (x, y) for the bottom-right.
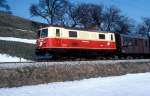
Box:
(0, 37), (36, 44)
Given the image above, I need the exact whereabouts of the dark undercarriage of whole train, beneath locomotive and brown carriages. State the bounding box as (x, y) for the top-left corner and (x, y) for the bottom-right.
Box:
(36, 48), (150, 60)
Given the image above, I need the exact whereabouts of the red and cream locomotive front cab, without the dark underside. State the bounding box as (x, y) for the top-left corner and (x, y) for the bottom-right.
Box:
(36, 27), (61, 49)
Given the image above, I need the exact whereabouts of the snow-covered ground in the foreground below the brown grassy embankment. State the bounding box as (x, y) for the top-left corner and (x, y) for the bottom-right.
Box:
(0, 73), (150, 96)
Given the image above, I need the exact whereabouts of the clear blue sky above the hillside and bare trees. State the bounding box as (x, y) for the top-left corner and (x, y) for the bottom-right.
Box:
(7, 0), (150, 22)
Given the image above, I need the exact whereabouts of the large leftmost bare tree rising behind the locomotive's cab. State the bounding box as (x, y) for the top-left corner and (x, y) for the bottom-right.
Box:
(30, 0), (68, 25)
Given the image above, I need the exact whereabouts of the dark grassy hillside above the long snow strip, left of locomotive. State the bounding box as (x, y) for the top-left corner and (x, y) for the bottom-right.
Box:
(0, 13), (46, 39)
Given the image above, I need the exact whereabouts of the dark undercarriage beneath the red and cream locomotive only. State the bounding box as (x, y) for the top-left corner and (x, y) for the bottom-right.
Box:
(36, 48), (116, 60)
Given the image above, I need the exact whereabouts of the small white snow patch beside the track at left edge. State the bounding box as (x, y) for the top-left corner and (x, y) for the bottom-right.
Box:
(0, 54), (27, 62)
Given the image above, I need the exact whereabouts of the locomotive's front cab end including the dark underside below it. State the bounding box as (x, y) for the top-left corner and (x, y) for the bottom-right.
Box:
(35, 27), (61, 56)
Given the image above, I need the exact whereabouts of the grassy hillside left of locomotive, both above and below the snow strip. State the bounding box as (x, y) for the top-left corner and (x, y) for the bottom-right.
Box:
(0, 13), (46, 60)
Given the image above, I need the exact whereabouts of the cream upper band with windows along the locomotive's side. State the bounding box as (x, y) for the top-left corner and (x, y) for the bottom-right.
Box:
(47, 27), (115, 42)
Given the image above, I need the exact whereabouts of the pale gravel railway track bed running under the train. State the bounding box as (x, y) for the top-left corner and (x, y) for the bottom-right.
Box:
(0, 59), (150, 69)
